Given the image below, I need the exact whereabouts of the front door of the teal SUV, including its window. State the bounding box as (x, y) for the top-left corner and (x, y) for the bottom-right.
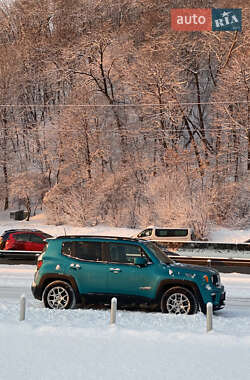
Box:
(106, 242), (155, 298)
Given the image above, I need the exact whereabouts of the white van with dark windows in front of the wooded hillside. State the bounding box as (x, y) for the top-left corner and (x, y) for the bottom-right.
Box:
(134, 226), (195, 241)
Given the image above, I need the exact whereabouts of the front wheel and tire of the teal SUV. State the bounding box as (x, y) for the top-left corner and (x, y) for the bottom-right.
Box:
(161, 286), (198, 315)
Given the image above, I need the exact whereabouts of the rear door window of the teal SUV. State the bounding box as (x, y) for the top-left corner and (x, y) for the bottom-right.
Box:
(62, 241), (102, 261)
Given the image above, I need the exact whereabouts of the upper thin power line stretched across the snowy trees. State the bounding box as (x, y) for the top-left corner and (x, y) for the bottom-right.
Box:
(0, 100), (250, 108)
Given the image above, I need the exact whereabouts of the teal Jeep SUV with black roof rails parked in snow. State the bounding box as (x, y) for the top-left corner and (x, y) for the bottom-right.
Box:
(32, 236), (225, 314)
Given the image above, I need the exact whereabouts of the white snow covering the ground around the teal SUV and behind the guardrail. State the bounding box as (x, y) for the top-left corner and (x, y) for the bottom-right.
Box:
(0, 214), (250, 380)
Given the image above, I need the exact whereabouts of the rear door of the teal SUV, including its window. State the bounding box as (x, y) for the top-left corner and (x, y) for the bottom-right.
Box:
(62, 241), (108, 295)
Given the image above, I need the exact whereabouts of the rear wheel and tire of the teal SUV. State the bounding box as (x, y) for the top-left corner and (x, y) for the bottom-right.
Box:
(43, 281), (76, 310)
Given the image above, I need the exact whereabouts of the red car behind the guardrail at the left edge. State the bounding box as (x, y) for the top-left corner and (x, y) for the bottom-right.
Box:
(0, 229), (52, 251)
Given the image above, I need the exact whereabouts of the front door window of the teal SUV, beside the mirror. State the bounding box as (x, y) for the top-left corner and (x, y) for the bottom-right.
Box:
(108, 243), (148, 264)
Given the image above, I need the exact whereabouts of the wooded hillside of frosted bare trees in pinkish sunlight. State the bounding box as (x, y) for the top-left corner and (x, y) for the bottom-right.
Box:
(0, 0), (250, 237)
